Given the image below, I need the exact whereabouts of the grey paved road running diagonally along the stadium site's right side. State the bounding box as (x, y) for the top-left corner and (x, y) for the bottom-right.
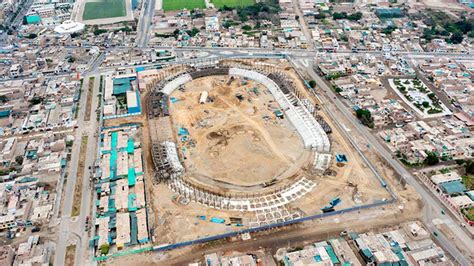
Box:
(306, 63), (474, 265)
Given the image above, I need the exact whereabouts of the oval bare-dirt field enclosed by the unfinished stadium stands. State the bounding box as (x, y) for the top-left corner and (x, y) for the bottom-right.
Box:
(170, 76), (310, 190)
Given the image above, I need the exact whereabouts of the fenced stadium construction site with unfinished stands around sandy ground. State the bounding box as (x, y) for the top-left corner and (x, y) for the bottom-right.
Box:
(138, 60), (392, 245)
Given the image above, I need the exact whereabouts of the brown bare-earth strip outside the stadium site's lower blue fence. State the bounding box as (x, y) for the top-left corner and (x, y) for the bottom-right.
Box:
(107, 198), (420, 265)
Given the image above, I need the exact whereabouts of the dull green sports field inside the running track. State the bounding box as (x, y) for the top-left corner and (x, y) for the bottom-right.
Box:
(82, 0), (127, 20)
